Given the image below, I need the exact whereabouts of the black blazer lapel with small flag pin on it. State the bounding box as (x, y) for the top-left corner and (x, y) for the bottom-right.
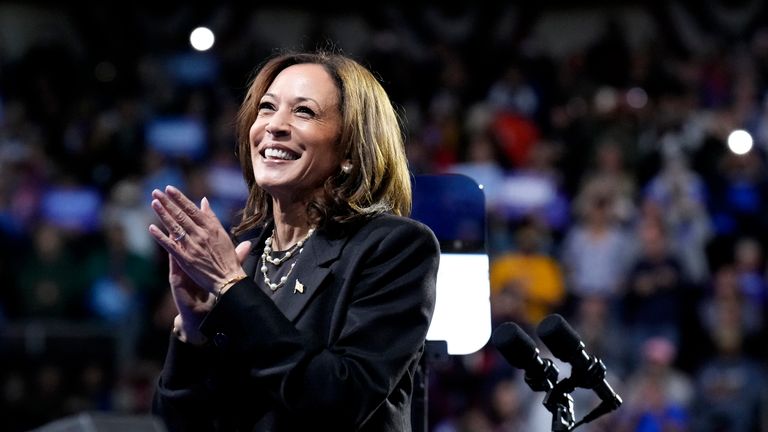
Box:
(273, 230), (346, 321)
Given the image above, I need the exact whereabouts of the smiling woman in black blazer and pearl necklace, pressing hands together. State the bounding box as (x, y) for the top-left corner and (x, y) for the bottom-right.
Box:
(149, 52), (439, 431)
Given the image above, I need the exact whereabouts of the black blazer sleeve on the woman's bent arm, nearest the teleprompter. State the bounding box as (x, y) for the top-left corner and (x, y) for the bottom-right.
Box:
(195, 217), (440, 429)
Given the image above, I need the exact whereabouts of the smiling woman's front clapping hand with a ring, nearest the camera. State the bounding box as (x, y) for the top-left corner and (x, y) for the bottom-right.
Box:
(149, 186), (245, 294)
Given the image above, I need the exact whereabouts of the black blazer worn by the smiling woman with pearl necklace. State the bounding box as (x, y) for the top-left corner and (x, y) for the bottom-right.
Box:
(153, 215), (440, 432)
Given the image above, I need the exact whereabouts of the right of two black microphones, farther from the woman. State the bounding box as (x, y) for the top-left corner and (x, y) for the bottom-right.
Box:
(537, 314), (622, 412)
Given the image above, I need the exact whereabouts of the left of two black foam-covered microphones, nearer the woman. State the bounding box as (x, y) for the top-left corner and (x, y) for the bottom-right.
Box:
(491, 322), (559, 391)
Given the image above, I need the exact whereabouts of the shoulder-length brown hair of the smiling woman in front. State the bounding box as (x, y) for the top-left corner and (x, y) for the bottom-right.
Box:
(232, 51), (411, 235)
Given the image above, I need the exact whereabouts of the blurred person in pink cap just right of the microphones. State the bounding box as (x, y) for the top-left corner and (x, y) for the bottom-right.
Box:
(616, 336), (694, 432)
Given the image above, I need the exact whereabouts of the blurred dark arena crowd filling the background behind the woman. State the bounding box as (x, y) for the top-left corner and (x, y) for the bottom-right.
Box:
(0, 0), (768, 432)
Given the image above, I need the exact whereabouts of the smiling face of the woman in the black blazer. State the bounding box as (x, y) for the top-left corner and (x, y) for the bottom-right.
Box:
(249, 64), (341, 202)
